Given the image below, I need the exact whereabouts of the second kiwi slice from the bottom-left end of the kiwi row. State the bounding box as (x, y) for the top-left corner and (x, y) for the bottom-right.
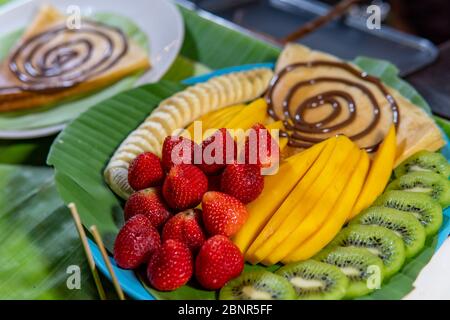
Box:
(275, 260), (349, 300)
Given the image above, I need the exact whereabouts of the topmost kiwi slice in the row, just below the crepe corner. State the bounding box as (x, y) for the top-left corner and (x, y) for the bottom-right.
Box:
(394, 151), (450, 179)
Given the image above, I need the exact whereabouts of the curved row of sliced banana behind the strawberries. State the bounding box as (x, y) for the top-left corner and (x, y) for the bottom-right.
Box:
(104, 68), (273, 199)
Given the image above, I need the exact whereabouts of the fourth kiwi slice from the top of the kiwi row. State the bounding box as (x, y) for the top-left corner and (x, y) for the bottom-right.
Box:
(350, 207), (426, 258)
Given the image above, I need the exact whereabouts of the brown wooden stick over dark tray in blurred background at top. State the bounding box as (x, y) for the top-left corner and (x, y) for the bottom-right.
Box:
(281, 0), (360, 43)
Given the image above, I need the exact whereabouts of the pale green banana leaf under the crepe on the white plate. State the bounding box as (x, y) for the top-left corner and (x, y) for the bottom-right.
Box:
(0, 13), (149, 130)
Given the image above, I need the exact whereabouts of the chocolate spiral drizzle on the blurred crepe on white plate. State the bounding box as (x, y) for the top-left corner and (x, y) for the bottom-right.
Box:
(0, 20), (128, 93)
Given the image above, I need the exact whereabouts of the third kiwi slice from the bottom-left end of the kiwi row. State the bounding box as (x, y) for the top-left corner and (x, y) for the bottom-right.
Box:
(314, 247), (384, 299)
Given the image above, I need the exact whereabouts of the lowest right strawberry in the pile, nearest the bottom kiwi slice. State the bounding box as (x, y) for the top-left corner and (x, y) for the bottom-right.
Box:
(195, 235), (244, 290)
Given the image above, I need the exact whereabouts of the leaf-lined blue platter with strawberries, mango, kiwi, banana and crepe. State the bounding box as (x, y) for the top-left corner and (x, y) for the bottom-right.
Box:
(44, 22), (450, 300)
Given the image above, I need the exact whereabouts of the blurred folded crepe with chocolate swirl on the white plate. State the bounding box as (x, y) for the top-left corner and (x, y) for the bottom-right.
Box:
(0, 6), (150, 112)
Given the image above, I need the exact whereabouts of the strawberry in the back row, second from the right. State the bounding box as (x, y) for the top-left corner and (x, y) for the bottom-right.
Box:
(199, 128), (237, 175)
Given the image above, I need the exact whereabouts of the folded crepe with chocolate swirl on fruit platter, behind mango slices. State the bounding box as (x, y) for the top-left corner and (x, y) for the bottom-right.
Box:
(271, 44), (445, 164)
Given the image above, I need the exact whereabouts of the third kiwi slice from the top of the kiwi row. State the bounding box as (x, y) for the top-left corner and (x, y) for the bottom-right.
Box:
(374, 190), (442, 236)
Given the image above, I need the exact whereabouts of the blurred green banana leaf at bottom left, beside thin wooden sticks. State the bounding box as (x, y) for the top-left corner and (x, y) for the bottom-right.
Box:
(0, 165), (116, 299)
